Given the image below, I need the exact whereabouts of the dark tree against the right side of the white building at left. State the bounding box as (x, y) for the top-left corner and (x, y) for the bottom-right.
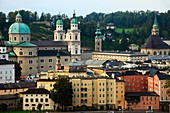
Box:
(14, 62), (22, 80)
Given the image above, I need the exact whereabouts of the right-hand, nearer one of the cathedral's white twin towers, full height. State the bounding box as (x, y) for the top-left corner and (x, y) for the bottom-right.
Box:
(66, 12), (81, 62)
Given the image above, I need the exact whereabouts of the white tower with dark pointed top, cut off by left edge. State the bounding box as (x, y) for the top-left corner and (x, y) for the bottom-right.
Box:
(0, 32), (8, 60)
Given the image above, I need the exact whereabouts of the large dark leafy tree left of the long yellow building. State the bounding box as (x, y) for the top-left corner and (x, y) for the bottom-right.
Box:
(51, 78), (73, 110)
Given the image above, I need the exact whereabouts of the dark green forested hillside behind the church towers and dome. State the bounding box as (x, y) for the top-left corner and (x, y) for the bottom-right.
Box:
(0, 10), (170, 50)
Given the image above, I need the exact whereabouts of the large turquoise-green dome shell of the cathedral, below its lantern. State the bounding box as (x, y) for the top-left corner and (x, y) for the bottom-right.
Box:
(8, 22), (31, 34)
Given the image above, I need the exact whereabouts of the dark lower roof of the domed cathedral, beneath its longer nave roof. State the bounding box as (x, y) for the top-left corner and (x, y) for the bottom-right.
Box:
(38, 50), (70, 56)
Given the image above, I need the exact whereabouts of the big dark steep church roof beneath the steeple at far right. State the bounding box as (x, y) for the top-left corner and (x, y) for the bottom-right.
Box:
(142, 35), (170, 49)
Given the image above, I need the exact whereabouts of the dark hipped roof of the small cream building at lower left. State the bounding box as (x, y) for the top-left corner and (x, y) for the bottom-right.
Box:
(21, 88), (50, 94)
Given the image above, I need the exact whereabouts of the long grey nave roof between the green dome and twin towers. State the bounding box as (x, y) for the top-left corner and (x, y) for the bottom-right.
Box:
(31, 41), (67, 47)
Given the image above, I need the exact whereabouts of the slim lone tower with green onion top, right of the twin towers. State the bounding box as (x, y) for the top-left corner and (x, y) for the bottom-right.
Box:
(95, 22), (102, 51)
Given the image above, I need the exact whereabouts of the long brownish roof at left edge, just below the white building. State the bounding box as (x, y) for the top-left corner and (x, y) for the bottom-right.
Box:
(0, 82), (36, 90)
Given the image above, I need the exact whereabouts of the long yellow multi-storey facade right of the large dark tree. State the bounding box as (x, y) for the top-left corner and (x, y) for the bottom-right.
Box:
(70, 77), (116, 110)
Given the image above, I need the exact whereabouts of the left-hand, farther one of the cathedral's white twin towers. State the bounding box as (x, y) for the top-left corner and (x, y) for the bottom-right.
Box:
(54, 14), (65, 41)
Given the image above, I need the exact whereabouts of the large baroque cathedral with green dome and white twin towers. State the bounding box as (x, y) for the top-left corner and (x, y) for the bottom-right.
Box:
(0, 12), (81, 75)
